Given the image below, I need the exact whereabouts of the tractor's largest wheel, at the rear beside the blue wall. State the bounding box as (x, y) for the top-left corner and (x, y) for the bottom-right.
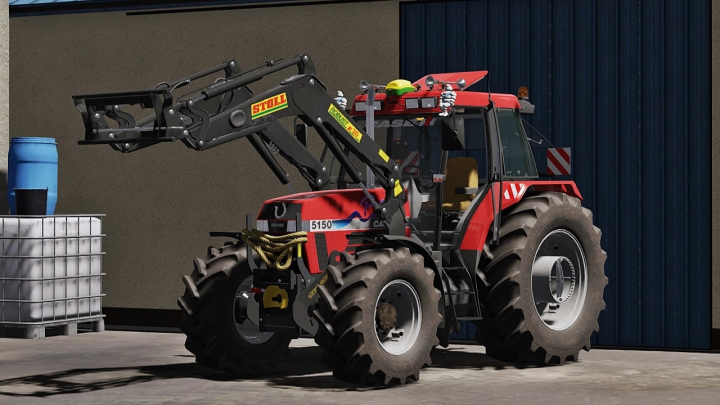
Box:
(476, 192), (607, 365)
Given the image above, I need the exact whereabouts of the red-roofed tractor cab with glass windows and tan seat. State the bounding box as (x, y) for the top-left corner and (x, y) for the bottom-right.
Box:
(338, 71), (538, 248)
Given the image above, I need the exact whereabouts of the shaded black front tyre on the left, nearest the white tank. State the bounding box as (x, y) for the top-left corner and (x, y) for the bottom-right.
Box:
(178, 244), (292, 372)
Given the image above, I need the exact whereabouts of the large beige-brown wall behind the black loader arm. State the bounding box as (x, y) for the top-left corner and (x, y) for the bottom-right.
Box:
(5, 2), (399, 309)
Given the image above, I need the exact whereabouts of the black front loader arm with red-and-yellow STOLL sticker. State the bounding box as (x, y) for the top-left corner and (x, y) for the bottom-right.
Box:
(73, 54), (407, 230)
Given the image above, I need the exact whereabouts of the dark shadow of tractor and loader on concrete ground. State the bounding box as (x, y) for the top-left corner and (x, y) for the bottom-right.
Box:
(0, 347), (528, 402)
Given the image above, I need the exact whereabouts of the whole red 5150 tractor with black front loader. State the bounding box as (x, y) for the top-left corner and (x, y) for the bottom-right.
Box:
(73, 54), (607, 385)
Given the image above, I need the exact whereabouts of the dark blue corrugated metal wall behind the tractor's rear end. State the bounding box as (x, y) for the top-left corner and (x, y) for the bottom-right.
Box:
(401, 0), (711, 349)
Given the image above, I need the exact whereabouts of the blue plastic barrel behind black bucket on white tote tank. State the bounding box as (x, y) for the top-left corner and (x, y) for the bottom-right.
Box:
(8, 137), (58, 215)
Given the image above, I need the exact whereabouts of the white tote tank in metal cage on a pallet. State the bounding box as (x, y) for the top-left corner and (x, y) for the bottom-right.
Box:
(0, 214), (105, 338)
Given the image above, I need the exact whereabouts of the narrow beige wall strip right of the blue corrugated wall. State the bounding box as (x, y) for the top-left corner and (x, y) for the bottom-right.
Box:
(712, 1), (720, 332)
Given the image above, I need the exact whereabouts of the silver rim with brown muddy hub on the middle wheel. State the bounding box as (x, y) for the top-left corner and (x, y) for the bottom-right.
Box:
(373, 280), (422, 356)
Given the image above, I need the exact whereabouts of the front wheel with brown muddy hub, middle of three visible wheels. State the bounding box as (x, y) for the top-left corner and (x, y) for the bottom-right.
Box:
(314, 248), (442, 385)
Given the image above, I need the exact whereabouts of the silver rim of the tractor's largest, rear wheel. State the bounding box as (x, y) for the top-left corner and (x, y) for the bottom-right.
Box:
(531, 229), (588, 330)
